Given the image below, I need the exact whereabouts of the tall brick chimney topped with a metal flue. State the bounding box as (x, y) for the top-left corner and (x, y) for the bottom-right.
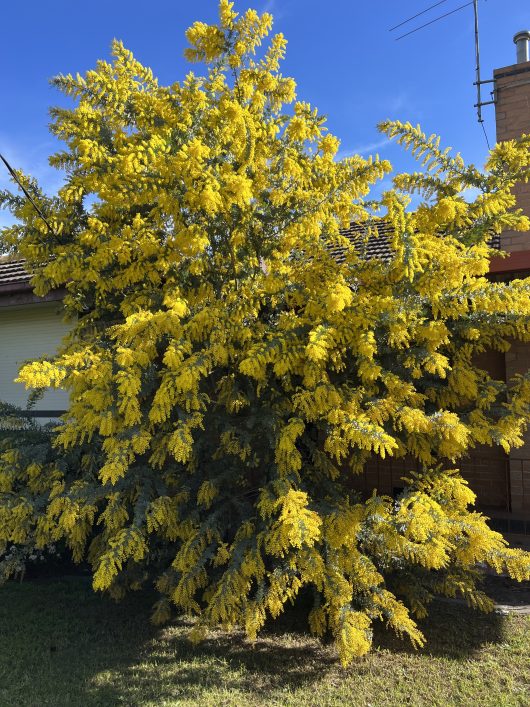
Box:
(493, 30), (530, 258)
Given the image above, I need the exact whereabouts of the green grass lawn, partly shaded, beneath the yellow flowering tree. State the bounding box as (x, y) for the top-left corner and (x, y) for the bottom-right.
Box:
(0, 578), (530, 707)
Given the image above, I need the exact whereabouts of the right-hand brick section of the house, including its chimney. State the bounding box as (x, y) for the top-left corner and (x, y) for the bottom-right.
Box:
(346, 31), (530, 535)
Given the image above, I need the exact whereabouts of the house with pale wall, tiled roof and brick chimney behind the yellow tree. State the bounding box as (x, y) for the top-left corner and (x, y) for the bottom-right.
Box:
(0, 32), (530, 534)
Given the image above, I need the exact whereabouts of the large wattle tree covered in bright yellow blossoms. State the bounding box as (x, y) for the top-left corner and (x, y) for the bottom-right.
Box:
(0, 0), (530, 663)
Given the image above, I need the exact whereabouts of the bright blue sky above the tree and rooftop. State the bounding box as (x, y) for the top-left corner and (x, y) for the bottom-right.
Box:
(0, 0), (530, 225)
